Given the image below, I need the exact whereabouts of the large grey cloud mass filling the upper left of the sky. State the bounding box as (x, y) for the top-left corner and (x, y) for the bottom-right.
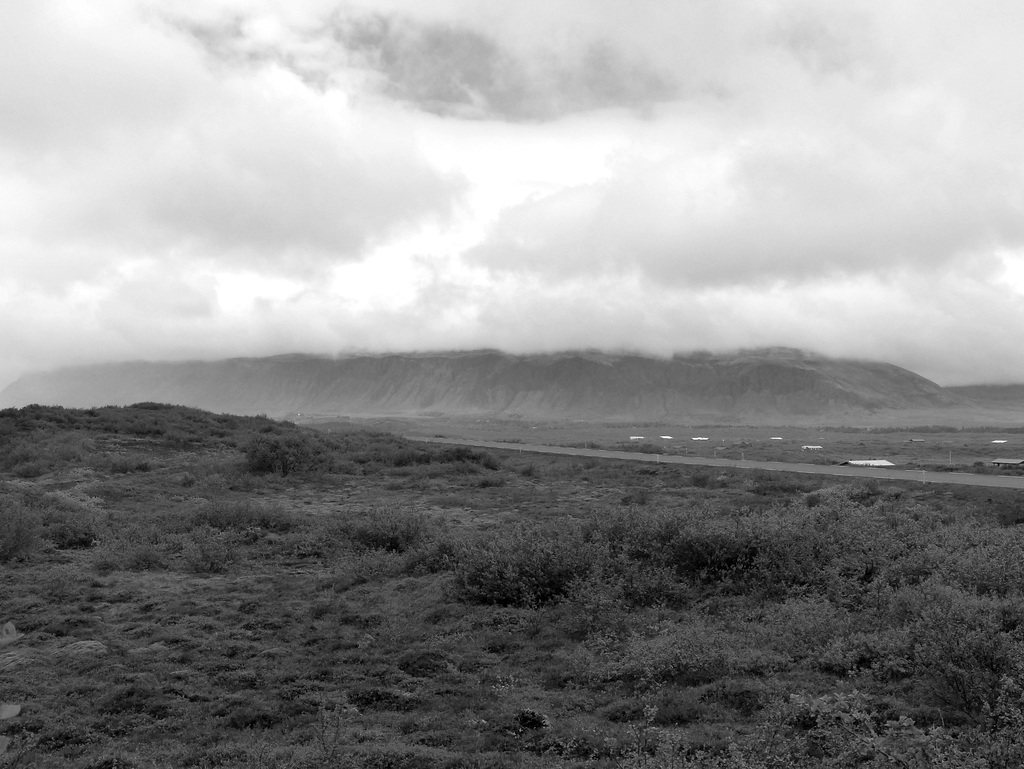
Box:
(0, 2), (464, 288)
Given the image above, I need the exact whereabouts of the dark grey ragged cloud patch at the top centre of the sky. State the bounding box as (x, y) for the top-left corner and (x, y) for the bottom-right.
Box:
(178, 12), (680, 122)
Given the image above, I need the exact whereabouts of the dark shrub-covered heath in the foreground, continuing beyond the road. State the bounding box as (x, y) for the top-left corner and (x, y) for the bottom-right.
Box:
(0, 403), (1024, 769)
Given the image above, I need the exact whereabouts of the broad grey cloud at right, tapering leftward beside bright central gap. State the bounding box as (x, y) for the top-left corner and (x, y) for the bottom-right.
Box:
(471, 132), (1024, 285)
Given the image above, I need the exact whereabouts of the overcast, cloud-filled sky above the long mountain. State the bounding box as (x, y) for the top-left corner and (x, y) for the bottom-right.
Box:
(0, 0), (1024, 388)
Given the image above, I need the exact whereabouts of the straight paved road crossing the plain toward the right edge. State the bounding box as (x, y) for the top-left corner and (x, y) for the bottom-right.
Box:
(406, 435), (1024, 489)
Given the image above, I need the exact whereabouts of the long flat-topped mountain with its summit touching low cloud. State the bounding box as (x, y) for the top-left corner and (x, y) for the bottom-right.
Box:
(0, 348), (966, 423)
